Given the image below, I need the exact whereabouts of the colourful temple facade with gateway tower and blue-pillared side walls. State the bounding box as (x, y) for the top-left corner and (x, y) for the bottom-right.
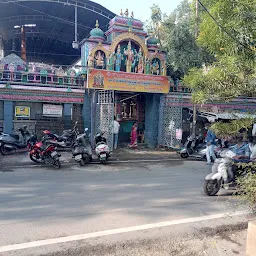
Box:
(0, 11), (256, 147)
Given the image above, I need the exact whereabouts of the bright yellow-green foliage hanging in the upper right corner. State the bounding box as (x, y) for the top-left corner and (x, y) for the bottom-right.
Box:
(184, 0), (256, 103)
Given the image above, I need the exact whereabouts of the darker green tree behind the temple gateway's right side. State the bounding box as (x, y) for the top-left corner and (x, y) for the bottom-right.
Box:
(148, 0), (214, 79)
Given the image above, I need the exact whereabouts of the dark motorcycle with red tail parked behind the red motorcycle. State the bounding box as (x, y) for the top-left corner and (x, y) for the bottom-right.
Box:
(43, 122), (79, 148)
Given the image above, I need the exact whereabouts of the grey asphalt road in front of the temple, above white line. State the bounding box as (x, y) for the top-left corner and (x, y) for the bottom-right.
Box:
(0, 157), (249, 255)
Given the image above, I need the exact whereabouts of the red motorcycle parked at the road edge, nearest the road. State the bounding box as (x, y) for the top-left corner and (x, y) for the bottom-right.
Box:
(29, 141), (61, 169)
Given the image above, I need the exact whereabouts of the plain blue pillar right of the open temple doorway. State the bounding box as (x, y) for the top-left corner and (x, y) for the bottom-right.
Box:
(144, 93), (160, 148)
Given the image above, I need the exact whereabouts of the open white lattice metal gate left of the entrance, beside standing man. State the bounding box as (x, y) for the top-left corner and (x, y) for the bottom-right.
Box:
(94, 91), (115, 150)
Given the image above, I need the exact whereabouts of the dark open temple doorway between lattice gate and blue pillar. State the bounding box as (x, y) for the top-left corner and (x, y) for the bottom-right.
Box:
(115, 92), (146, 146)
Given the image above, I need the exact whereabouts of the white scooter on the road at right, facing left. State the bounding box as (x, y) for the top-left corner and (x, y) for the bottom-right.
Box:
(203, 149), (254, 196)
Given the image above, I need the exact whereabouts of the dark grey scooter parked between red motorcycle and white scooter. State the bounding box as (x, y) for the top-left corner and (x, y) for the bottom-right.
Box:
(72, 128), (92, 166)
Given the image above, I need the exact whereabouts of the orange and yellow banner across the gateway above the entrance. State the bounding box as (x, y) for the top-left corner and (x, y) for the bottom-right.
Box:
(87, 69), (170, 93)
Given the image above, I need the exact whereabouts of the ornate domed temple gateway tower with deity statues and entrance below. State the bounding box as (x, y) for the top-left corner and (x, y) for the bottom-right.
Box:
(81, 10), (170, 146)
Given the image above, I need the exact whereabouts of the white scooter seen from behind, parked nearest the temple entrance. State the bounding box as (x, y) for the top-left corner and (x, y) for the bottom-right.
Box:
(95, 132), (110, 164)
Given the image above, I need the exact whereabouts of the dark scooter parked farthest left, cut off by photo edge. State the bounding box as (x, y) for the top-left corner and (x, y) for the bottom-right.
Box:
(0, 125), (32, 155)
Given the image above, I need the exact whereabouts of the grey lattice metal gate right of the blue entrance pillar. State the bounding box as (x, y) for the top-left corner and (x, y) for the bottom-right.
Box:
(158, 95), (182, 147)
